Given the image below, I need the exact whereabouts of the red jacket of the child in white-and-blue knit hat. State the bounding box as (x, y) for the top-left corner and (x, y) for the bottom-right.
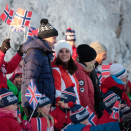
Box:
(101, 76), (130, 106)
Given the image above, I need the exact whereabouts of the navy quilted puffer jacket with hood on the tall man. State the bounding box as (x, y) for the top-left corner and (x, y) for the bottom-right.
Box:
(21, 36), (55, 107)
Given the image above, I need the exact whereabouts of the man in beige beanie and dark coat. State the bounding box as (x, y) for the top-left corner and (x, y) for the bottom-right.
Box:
(90, 42), (107, 118)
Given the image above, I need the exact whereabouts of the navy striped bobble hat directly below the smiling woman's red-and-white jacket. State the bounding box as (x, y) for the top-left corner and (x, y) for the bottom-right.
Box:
(60, 83), (77, 103)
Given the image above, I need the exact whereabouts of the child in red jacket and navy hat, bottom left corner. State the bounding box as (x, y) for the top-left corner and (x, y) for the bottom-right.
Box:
(0, 84), (33, 131)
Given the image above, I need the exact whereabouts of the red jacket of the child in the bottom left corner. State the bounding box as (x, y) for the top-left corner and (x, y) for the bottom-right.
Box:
(0, 112), (24, 131)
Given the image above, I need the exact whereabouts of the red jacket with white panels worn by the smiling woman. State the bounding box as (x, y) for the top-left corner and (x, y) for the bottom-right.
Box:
(51, 60), (80, 104)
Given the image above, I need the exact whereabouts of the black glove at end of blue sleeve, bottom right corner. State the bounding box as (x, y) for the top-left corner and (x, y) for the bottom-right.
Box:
(119, 119), (131, 131)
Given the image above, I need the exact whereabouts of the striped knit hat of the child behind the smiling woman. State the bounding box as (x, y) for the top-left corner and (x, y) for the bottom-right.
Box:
(65, 28), (76, 41)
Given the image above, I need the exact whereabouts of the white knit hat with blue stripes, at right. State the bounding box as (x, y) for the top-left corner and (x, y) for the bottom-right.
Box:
(110, 63), (127, 79)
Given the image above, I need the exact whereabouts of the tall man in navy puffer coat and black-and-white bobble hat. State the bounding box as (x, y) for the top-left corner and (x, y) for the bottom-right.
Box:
(21, 19), (58, 119)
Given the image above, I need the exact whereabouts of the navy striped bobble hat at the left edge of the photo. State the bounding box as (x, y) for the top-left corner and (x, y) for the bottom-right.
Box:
(0, 84), (18, 108)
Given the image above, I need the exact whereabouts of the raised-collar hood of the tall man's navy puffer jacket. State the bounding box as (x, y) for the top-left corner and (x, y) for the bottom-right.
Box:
(22, 35), (53, 53)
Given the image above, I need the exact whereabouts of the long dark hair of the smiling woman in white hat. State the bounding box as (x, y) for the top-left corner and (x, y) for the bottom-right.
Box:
(55, 57), (78, 75)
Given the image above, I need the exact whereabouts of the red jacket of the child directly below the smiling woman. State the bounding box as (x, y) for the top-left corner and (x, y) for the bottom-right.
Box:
(50, 106), (71, 130)
